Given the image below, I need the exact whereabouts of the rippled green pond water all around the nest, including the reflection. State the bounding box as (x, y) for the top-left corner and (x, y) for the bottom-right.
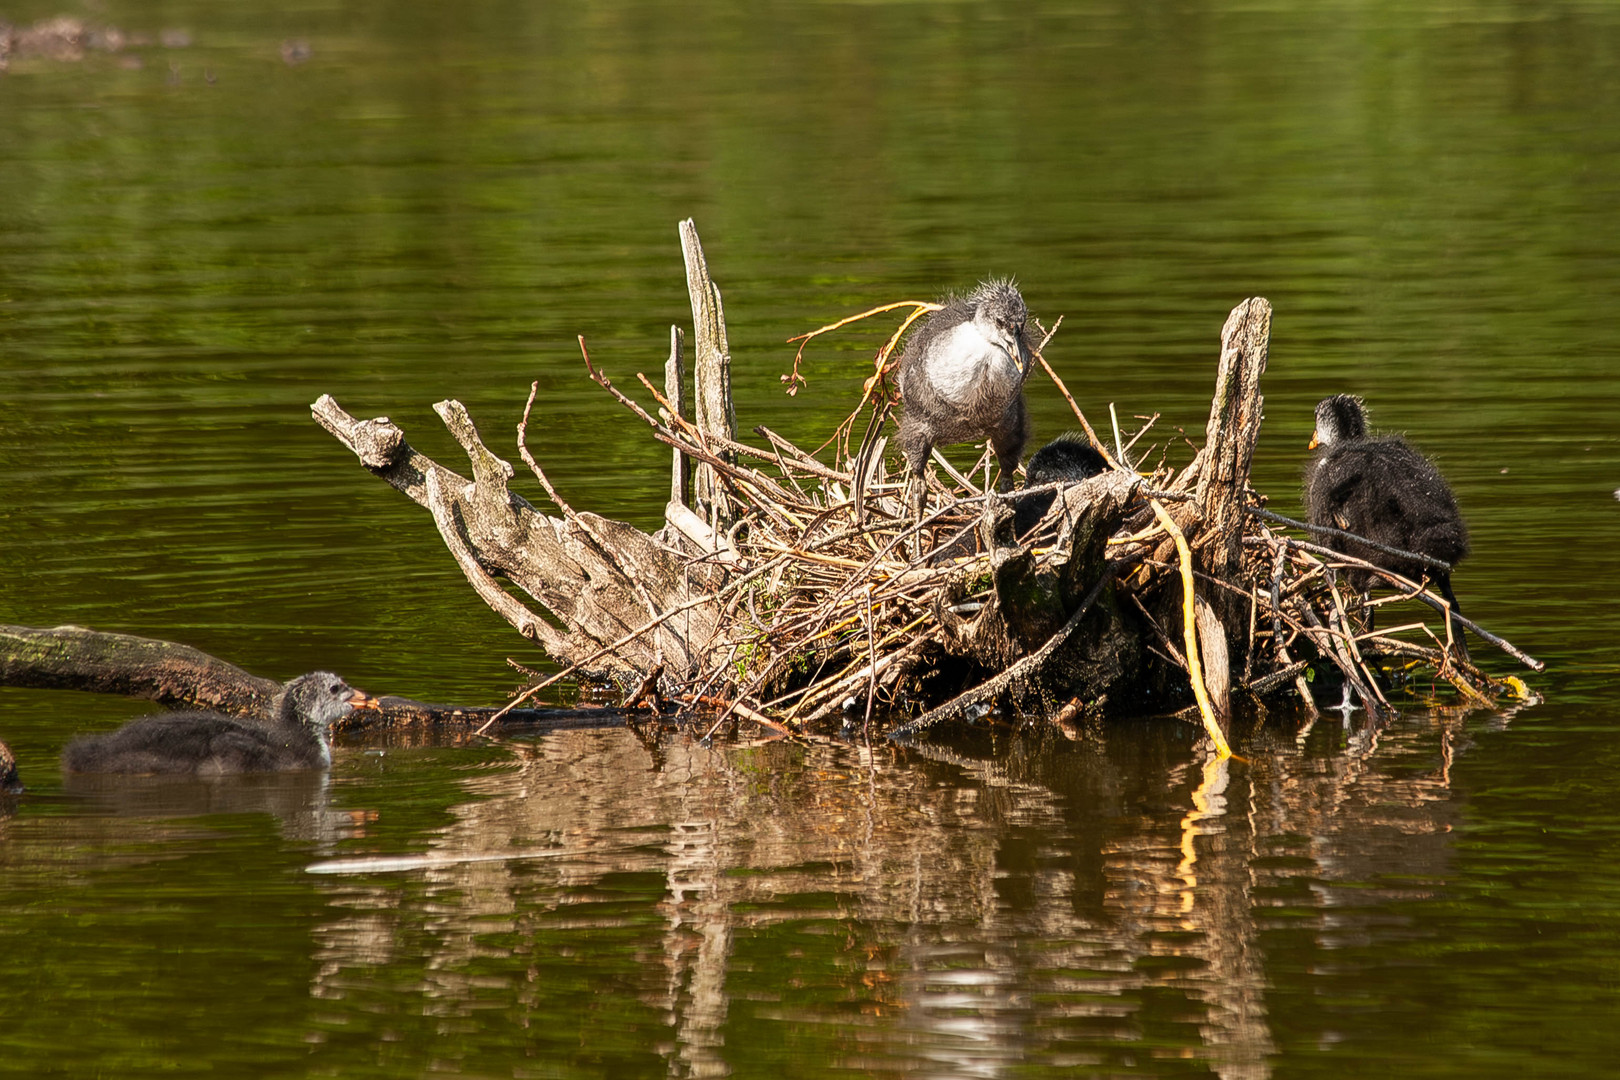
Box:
(0, 0), (1620, 1077)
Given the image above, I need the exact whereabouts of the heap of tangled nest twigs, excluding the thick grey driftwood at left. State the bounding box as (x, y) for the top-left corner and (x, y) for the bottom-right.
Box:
(476, 301), (1541, 751)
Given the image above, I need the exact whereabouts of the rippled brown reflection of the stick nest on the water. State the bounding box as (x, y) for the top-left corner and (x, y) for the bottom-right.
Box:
(294, 712), (1490, 1077)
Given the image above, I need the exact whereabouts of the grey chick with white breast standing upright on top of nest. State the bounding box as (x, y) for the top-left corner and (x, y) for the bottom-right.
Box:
(901, 280), (1035, 513)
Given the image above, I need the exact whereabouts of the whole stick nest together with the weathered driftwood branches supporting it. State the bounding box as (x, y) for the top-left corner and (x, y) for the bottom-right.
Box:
(313, 222), (1539, 750)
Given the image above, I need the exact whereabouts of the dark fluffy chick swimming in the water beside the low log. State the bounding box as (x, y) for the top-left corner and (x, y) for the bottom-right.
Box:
(62, 672), (379, 776)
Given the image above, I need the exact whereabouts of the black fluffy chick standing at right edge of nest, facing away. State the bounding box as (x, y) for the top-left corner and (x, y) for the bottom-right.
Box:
(1306, 393), (1468, 656)
